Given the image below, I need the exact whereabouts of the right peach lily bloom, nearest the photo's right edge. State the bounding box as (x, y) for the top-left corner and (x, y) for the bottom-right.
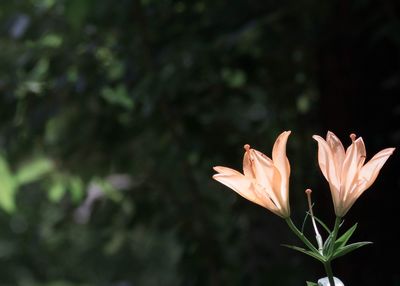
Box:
(313, 131), (395, 217)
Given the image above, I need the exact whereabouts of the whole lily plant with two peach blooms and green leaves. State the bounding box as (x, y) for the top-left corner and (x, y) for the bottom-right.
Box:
(213, 131), (395, 286)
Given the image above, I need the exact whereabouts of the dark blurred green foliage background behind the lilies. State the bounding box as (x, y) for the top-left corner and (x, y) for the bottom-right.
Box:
(0, 0), (400, 286)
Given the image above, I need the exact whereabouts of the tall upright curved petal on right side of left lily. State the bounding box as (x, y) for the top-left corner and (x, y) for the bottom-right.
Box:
(272, 131), (291, 197)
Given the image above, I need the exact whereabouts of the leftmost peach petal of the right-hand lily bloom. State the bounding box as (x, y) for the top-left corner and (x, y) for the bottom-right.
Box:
(313, 135), (340, 190)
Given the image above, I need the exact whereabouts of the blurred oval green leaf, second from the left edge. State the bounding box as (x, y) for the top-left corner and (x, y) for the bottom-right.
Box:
(15, 157), (54, 185)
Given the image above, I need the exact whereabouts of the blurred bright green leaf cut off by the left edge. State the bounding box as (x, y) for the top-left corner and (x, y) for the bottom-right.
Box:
(0, 155), (16, 213)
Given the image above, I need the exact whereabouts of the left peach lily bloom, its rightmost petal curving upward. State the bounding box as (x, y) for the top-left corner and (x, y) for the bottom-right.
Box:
(213, 131), (290, 218)
